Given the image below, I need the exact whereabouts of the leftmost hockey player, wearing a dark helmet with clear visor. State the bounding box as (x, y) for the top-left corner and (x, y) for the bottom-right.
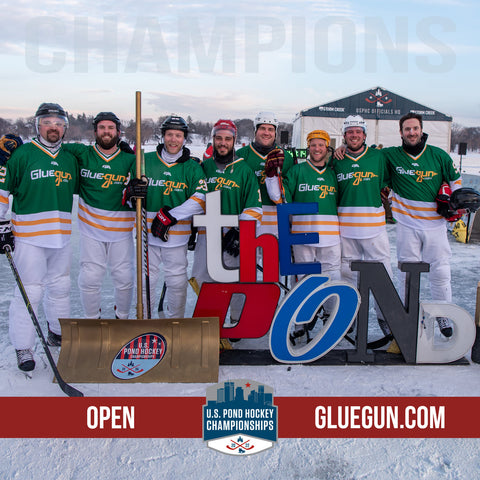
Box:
(0, 103), (78, 371)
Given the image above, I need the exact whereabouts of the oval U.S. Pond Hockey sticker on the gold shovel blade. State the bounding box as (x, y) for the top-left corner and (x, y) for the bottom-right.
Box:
(112, 332), (167, 380)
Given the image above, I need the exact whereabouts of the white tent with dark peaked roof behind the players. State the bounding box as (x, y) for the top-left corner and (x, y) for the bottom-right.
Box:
(292, 87), (452, 152)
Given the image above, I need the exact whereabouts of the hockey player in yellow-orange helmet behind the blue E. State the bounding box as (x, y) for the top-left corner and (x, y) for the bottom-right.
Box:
(265, 130), (340, 280)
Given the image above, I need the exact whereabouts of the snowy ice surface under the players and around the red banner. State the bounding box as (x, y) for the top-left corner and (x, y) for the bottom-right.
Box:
(0, 146), (480, 480)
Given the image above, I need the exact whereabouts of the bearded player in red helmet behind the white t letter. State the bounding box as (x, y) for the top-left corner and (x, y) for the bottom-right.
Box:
(192, 120), (262, 325)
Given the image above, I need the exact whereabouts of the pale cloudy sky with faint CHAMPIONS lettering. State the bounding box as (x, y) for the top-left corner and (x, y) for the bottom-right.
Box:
(0, 0), (480, 126)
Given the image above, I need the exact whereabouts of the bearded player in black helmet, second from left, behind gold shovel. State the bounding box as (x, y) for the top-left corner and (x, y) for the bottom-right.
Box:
(64, 112), (139, 319)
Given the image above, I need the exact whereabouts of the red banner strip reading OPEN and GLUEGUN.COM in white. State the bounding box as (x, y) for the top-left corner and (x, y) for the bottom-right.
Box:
(0, 397), (480, 438)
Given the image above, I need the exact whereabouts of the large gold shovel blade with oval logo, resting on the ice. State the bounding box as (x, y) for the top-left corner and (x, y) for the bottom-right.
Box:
(58, 317), (219, 383)
